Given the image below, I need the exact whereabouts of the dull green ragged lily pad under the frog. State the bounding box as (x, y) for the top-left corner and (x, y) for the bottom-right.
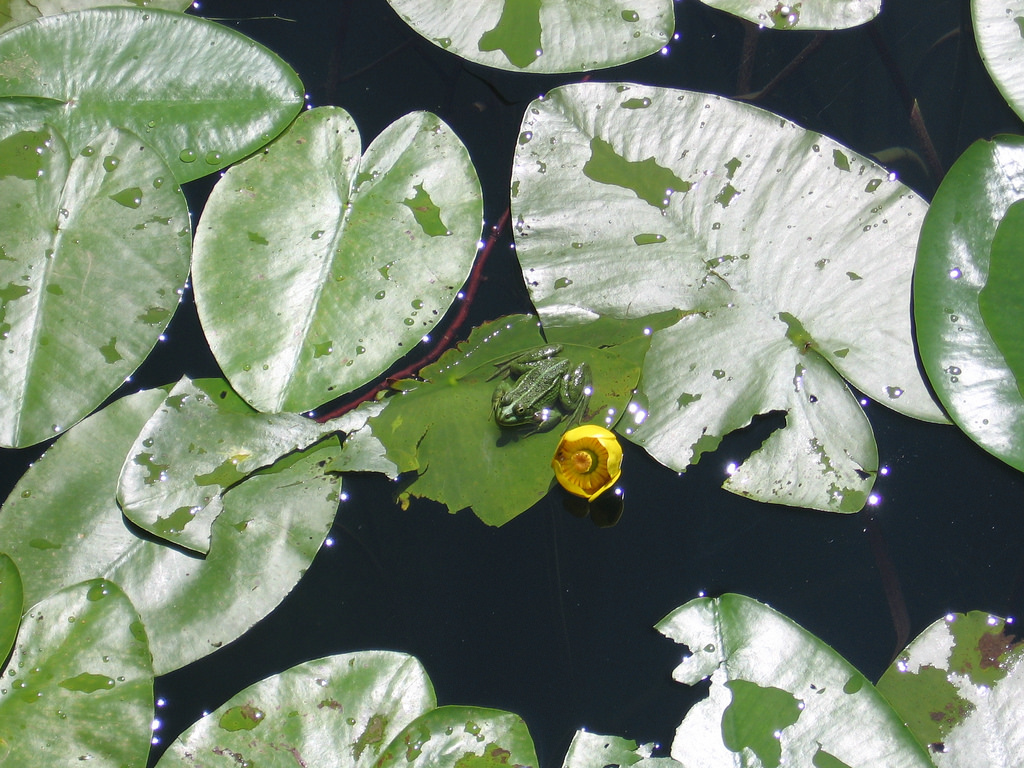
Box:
(370, 315), (646, 525)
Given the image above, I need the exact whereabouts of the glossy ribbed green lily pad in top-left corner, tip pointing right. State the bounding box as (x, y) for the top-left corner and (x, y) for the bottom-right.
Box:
(0, 7), (303, 182)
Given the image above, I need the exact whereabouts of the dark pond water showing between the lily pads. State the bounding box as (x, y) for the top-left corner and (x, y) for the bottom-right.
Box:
(0, 0), (1024, 767)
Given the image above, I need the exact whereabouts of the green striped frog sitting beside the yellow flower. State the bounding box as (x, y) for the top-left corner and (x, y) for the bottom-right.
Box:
(488, 344), (591, 431)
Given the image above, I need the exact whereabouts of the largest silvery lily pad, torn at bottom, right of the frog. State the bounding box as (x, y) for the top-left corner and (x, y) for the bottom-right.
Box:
(512, 83), (943, 512)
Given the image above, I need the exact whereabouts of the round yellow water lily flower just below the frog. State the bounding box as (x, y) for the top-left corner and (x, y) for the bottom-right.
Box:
(551, 424), (623, 502)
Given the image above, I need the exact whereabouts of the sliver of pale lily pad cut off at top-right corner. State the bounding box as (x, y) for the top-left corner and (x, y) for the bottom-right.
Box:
(971, 0), (1024, 119)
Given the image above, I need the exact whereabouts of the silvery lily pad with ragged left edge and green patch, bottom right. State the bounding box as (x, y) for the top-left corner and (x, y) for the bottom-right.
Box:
(656, 594), (932, 768)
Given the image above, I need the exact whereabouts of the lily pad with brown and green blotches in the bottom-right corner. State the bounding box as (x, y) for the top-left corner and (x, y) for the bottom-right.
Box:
(879, 611), (1024, 768)
